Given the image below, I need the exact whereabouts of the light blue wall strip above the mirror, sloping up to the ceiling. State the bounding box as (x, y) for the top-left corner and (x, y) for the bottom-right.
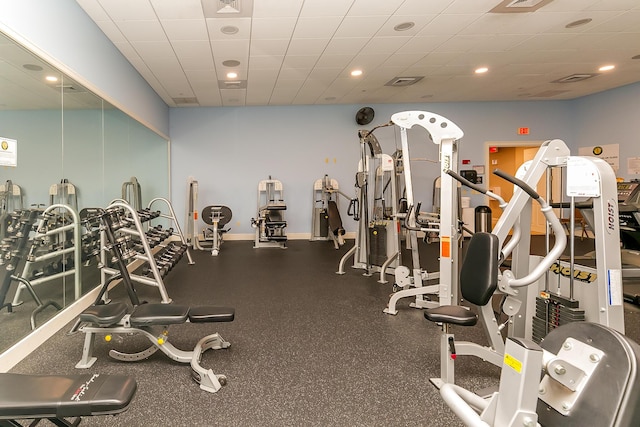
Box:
(0, 0), (169, 136)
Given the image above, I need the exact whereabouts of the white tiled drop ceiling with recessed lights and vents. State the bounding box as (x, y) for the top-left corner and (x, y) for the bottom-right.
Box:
(77, 0), (640, 107)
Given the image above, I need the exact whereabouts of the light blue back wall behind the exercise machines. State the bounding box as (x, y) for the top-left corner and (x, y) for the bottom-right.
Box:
(170, 101), (574, 233)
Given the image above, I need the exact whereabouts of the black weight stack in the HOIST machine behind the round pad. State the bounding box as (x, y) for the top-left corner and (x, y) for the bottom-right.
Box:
(532, 292), (585, 343)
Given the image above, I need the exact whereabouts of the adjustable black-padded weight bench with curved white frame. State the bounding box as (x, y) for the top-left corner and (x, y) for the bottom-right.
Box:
(76, 303), (235, 393)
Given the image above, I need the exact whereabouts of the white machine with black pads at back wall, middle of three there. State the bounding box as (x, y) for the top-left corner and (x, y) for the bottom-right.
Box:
(251, 176), (287, 249)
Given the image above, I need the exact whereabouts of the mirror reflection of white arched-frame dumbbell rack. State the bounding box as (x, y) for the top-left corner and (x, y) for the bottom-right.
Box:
(13, 204), (82, 306)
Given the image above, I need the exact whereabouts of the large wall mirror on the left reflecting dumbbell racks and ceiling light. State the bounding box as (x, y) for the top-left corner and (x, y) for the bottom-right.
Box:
(0, 33), (169, 353)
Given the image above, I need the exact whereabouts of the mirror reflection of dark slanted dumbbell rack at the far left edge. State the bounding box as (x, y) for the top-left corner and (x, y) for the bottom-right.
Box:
(0, 209), (61, 329)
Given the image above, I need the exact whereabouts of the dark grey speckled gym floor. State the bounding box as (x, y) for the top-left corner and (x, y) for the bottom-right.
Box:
(6, 237), (640, 426)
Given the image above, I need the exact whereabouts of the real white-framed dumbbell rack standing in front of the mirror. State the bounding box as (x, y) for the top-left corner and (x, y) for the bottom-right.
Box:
(100, 199), (193, 303)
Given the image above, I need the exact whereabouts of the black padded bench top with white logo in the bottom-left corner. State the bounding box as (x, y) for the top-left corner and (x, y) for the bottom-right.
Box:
(0, 374), (137, 419)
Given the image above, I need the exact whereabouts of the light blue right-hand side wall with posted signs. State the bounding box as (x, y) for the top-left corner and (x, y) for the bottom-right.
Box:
(573, 83), (640, 180)
